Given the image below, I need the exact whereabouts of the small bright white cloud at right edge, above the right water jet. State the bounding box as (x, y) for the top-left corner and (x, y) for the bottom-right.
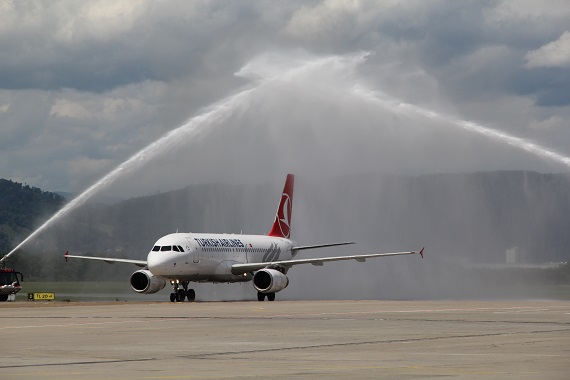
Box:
(525, 31), (570, 69)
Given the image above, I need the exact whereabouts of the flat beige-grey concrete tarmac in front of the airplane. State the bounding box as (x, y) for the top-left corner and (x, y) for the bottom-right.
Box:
(0, 301), (570, 380)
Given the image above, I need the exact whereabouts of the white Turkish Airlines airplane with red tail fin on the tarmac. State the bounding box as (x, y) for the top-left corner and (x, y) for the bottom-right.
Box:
(64, 174), (424, 302)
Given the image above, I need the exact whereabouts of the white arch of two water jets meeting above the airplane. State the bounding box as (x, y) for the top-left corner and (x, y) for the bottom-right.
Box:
(0, 52), (570, 264)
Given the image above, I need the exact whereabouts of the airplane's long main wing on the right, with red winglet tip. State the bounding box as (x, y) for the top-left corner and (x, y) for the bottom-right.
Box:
(232, 248), (424, 275)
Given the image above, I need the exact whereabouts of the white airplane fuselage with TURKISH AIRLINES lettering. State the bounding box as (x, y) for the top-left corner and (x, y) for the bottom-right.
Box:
(147, 233), (294, 282)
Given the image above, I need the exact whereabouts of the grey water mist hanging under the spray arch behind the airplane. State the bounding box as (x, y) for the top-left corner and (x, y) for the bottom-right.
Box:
(10, 51), (568, 300)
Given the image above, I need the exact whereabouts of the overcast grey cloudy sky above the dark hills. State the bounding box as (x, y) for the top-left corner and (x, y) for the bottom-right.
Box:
(0, 0), (570, 196)
